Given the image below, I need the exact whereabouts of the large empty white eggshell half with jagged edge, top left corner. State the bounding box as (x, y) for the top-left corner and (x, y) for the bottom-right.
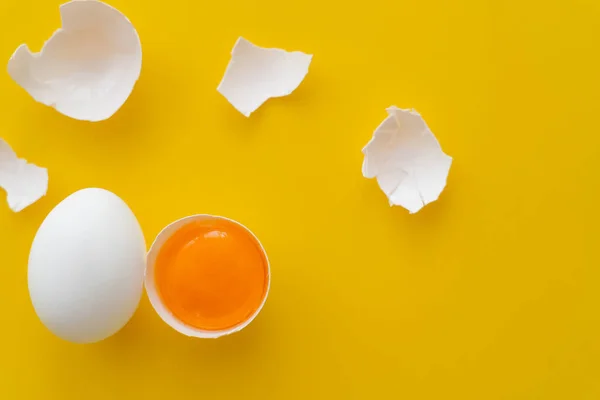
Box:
(8, 0), (142, 122)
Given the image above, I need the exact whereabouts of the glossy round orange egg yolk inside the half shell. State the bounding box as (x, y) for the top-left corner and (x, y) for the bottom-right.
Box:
(154, 219), (269, 331)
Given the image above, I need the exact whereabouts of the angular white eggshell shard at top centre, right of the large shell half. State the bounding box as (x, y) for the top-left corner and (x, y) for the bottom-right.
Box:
(217, 37), (312, 117)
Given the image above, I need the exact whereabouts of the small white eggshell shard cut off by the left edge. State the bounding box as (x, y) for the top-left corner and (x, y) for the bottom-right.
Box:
(0, 139), (48, 212)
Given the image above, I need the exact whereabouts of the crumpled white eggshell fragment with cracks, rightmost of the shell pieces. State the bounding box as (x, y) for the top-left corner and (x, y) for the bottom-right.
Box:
(362, 106), (452, 214)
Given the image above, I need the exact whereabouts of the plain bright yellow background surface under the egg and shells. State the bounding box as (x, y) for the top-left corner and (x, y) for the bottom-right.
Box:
(0, 0), (600, 400)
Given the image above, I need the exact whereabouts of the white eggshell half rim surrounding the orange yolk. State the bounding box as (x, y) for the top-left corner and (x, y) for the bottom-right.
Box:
(145, 214), (271, 339)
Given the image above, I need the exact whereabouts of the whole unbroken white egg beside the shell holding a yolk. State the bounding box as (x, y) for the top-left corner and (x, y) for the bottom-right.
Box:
(28, 189), (146, 343)
